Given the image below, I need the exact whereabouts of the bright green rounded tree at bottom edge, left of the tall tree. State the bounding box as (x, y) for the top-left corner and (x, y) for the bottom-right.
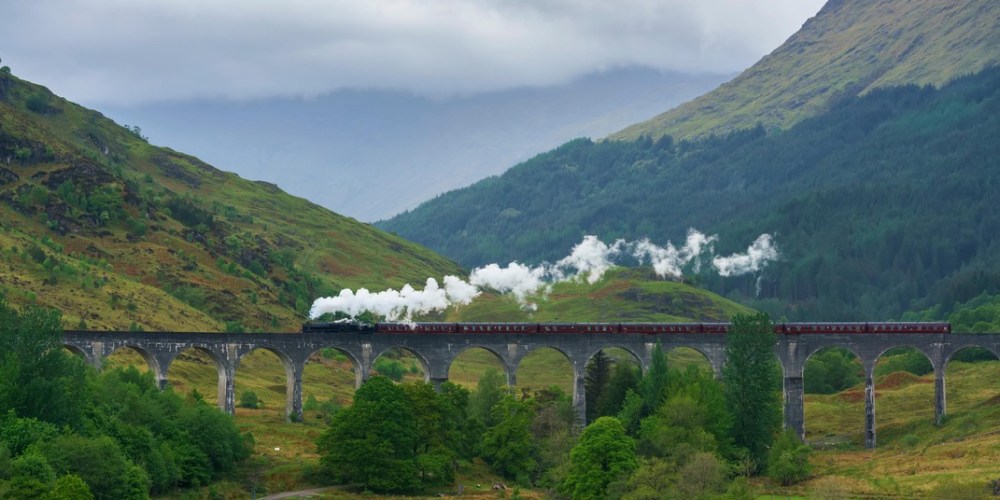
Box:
(561, 417), (638, 498)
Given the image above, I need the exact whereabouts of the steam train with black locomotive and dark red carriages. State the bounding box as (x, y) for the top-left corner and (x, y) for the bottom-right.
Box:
(301, 321), (951, 335)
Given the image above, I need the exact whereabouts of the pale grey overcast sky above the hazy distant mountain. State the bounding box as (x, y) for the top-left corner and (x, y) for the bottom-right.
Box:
(0, 0), (824, 106)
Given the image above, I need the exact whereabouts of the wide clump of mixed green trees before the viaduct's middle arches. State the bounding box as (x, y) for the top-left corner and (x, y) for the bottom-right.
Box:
(317, 314), (810, 499)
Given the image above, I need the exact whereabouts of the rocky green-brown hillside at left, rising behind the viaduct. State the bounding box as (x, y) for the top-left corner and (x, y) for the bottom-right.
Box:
(0, 68), (461, 331)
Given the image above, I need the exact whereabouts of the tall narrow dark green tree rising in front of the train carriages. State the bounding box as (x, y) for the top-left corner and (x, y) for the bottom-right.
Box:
(722, 313), (781, 465)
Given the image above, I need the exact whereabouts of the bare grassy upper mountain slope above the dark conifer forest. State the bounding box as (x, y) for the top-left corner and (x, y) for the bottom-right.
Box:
(611, 0), (1000, 140)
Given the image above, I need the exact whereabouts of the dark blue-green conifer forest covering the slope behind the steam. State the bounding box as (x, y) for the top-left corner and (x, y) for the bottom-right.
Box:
(378, 68), (1000, 320)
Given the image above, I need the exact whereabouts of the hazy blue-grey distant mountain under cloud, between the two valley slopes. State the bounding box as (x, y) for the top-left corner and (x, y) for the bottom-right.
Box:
(104, 68), (728, 220)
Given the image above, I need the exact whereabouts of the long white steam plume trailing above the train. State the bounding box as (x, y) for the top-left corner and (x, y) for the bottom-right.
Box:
(309, 229), (780, 321)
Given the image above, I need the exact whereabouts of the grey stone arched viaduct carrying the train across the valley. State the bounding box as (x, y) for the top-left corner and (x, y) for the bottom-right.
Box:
(64, 331), (1000, 448)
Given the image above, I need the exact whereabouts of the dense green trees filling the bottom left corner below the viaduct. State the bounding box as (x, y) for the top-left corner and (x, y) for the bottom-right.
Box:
(0, 298), (253, 500)
